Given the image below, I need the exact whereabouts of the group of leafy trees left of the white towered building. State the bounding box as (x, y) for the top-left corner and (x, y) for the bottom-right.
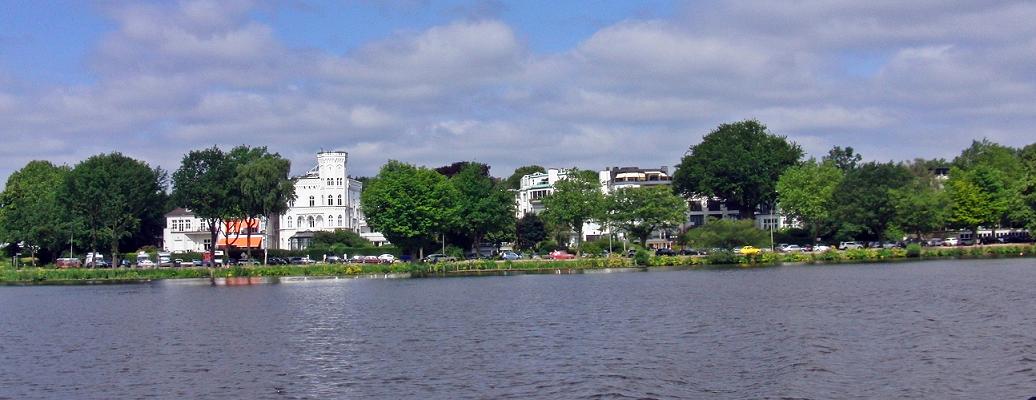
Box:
(0, 146), (294, 265)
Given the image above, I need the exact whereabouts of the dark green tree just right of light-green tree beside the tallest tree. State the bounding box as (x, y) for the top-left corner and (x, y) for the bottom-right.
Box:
(831, 163), (911, 239)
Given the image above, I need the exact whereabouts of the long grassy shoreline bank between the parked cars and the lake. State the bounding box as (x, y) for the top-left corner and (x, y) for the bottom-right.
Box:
(0, 246), (1036, 286)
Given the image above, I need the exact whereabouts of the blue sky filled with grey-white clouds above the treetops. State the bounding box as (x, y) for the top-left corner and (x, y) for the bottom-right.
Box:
(0, 0), (1036, 182)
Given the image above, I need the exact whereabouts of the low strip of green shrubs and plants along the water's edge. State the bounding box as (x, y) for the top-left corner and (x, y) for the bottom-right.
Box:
(0, 246), (1036, 284)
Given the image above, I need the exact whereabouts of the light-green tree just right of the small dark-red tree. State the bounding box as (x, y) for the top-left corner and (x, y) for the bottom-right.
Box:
(543, 169), (605, 246)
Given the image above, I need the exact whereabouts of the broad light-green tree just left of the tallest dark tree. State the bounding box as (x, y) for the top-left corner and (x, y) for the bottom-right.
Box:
(607, 185), (687, 247)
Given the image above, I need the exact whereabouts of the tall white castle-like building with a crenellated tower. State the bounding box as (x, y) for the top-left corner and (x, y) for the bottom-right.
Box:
(270, 151), (387, 250)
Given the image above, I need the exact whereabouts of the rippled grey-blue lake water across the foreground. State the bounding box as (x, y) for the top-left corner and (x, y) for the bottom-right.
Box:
(0, 259), (1036, 399)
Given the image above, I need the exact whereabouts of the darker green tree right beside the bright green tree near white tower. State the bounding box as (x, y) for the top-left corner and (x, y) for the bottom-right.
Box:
(450, 163), (515, 252)
